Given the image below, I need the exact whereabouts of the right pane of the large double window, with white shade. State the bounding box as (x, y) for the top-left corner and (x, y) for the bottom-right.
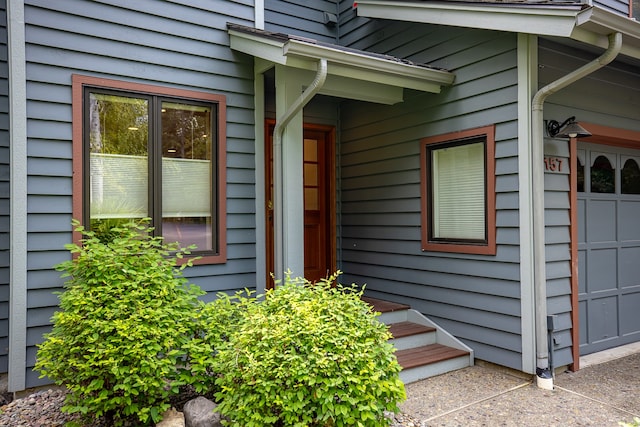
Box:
(162, 102), (215, 250)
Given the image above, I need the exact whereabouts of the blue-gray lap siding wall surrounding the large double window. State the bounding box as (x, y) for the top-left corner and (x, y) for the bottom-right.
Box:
(22, 0), (255, 387)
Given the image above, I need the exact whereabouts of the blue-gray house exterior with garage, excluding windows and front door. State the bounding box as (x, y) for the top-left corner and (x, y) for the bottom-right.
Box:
(0, 0), (640, 391)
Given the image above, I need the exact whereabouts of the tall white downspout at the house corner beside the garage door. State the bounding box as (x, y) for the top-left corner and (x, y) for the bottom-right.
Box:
(531, 33), (622, 389)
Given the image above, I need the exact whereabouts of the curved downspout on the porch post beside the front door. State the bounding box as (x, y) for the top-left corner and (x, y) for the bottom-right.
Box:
(273, 58), (327, 279)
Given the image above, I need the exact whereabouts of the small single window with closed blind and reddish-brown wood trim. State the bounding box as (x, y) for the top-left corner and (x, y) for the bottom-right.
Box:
(421, 126), (495, 254)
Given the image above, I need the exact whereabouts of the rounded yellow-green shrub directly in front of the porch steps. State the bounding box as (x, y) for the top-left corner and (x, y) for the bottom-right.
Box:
(215, 273), (405, 427)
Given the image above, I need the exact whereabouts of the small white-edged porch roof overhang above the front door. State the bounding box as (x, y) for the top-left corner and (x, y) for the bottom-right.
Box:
(228, 24), (455, 104)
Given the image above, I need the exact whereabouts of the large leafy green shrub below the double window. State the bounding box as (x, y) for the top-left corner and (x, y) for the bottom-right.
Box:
(36, 221), (205, 425)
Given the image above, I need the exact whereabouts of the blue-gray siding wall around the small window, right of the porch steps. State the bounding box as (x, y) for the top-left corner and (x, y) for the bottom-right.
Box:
(340, 20), (522, 368)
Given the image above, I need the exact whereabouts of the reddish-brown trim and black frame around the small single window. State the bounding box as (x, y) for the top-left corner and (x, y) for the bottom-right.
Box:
(420, 125), (496, 255)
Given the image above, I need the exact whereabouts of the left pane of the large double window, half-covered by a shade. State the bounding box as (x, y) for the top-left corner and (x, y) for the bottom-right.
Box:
(89, 93), (149, 229)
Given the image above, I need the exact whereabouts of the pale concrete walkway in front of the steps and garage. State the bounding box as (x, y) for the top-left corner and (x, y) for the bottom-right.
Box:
(401, 344), (640, 427)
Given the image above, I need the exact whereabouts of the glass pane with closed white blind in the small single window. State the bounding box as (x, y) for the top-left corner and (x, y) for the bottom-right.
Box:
(431, 142), (486, 240)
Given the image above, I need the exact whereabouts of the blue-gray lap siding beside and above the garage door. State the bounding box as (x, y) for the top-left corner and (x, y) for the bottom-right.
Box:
(539, 40), (640, 366)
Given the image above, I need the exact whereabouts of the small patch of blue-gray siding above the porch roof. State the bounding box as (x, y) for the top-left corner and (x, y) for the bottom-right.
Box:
(264, 0), (338, 43)
